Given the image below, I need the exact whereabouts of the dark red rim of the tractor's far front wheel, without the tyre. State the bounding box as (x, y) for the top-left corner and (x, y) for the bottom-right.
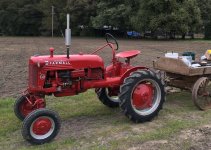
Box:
(19, 96), (45, 117)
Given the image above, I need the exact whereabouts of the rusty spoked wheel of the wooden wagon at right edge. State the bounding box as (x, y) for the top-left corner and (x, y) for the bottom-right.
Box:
(192, 77), (211, 110)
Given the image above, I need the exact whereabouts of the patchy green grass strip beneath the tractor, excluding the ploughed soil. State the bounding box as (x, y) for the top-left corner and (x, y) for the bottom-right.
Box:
(0, 90), (211, 150)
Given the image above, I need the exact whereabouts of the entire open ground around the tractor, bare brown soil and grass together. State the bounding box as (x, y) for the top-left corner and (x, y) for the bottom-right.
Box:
(0, 37), (211, 150)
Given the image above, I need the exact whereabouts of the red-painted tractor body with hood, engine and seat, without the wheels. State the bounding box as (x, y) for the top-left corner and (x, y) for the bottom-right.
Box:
(23, 43), (146, 110)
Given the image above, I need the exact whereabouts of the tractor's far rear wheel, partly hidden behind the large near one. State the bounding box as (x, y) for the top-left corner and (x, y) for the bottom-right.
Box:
(95, 88), (119, 108)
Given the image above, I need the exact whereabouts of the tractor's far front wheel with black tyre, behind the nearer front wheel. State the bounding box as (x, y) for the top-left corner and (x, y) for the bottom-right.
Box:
(14, 94), (46, 121)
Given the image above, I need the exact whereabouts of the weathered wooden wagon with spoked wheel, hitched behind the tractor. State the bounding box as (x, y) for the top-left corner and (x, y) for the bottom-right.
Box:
(153, 57), (211, 110)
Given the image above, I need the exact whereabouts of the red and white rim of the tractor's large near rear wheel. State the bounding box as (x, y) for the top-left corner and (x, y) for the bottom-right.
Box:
(131, 79), (161, 116)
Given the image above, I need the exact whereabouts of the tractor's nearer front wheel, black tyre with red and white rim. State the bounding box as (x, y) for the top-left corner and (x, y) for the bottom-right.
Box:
(22, 108), (61, 144)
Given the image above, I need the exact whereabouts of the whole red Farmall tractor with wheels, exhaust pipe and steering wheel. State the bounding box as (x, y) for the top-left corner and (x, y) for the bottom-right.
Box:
(14, 15), (165, 144)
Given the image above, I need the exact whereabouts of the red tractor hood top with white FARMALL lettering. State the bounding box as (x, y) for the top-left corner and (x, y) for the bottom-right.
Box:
(29, 54), (104, 70)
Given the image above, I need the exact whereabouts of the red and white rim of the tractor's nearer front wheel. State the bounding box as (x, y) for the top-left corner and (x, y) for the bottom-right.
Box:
(30, 116), (55, 140)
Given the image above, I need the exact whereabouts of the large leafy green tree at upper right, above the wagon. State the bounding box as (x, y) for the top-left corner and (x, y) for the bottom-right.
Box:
(131, 0), (201, 38)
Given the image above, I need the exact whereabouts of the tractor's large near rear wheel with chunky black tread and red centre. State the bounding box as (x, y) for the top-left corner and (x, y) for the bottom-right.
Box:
(119, 70), (165, 122)
